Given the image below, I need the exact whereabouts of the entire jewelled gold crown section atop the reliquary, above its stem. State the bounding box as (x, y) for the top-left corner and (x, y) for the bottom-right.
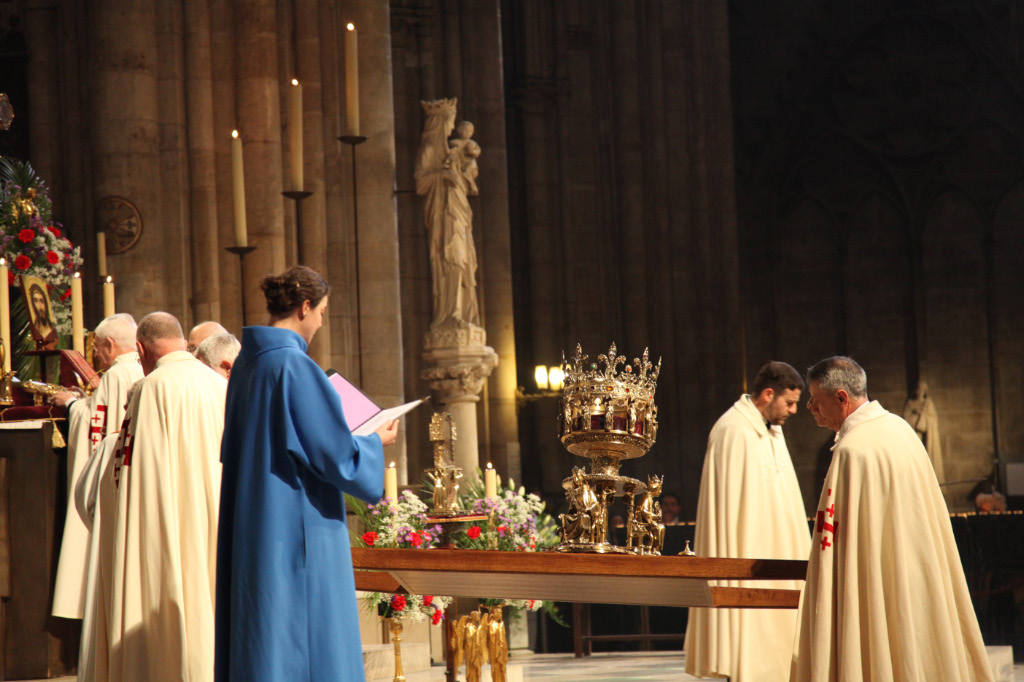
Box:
(559, 343), (662, 459)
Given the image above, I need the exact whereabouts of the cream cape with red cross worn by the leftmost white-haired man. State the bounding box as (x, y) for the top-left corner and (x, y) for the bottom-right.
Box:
(52, 351), (142, 619)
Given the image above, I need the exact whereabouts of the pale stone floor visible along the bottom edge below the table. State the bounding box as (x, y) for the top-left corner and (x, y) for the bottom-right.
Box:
(28, 651), (1024, 682)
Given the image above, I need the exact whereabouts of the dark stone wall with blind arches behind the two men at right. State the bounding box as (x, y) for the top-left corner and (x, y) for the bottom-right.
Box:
(730, 1), (1024, 509)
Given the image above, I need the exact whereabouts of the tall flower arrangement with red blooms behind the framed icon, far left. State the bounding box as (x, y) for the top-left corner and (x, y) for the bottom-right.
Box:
(0, 158), (82, 334)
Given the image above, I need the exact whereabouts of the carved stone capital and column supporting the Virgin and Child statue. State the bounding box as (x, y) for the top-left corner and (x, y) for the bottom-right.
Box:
(423, 319), (498, 479)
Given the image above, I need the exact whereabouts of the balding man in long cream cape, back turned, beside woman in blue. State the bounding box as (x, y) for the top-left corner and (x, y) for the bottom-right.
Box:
(108, 312), (227, 682)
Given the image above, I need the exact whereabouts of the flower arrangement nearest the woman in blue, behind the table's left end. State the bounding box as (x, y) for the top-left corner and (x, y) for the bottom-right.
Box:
(346, 491), (452, 625)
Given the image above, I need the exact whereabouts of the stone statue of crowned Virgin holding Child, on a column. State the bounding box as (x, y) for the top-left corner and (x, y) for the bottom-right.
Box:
(416, 98), (480, 333)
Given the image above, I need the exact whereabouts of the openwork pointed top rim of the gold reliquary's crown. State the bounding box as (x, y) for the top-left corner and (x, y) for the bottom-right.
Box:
(562, 343), (662, 400)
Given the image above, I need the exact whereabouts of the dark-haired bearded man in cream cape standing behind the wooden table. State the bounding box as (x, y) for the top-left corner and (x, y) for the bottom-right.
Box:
(685, 361), (810, 682)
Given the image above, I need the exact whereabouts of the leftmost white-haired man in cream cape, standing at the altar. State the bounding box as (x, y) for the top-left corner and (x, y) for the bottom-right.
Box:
(52, 312), (142, 619)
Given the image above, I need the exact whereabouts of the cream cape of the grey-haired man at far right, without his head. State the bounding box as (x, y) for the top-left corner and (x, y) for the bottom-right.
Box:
(791, 401), (992, 682)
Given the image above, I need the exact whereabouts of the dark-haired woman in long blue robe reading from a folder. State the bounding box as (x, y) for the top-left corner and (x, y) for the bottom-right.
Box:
(215, 265), (397, 682)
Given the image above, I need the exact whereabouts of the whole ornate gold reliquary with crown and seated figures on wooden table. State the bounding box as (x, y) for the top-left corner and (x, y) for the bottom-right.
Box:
(558, 344), (665, 555)
